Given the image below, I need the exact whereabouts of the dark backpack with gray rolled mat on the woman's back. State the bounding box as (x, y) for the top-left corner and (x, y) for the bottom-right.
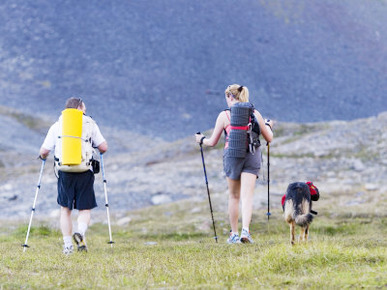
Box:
(228, 103), (260, 158)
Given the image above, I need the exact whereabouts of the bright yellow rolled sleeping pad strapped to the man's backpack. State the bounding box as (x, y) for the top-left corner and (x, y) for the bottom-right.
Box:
(62, 109), (83, 165)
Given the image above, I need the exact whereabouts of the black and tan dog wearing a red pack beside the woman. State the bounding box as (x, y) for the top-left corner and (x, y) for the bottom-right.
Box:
(282, 181), (320, 245)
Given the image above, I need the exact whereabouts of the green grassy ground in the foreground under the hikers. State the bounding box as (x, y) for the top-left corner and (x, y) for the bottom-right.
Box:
(0, 202), (387, 289)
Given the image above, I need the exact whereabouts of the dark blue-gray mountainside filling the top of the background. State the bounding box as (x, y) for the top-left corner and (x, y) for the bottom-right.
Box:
(0, 0), (387, 140)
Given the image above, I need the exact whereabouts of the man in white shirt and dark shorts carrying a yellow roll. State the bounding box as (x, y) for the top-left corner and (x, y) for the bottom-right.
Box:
(40, 98), (108, 255)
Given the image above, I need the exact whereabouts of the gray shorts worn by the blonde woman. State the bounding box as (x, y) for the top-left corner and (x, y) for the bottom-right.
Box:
(223, 148), (261, 180)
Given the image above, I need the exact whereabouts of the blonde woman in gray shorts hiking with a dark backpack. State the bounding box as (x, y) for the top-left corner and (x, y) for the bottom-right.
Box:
(196, 84), (273, 244)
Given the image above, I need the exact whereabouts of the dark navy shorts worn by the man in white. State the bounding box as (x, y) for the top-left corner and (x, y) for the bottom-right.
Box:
(57, 170), (97, 210)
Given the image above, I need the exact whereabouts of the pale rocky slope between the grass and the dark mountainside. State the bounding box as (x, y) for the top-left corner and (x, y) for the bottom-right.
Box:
(0, 107), (387, 220)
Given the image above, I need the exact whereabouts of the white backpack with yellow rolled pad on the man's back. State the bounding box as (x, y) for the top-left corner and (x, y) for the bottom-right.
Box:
(54, 109), (95, 172)
